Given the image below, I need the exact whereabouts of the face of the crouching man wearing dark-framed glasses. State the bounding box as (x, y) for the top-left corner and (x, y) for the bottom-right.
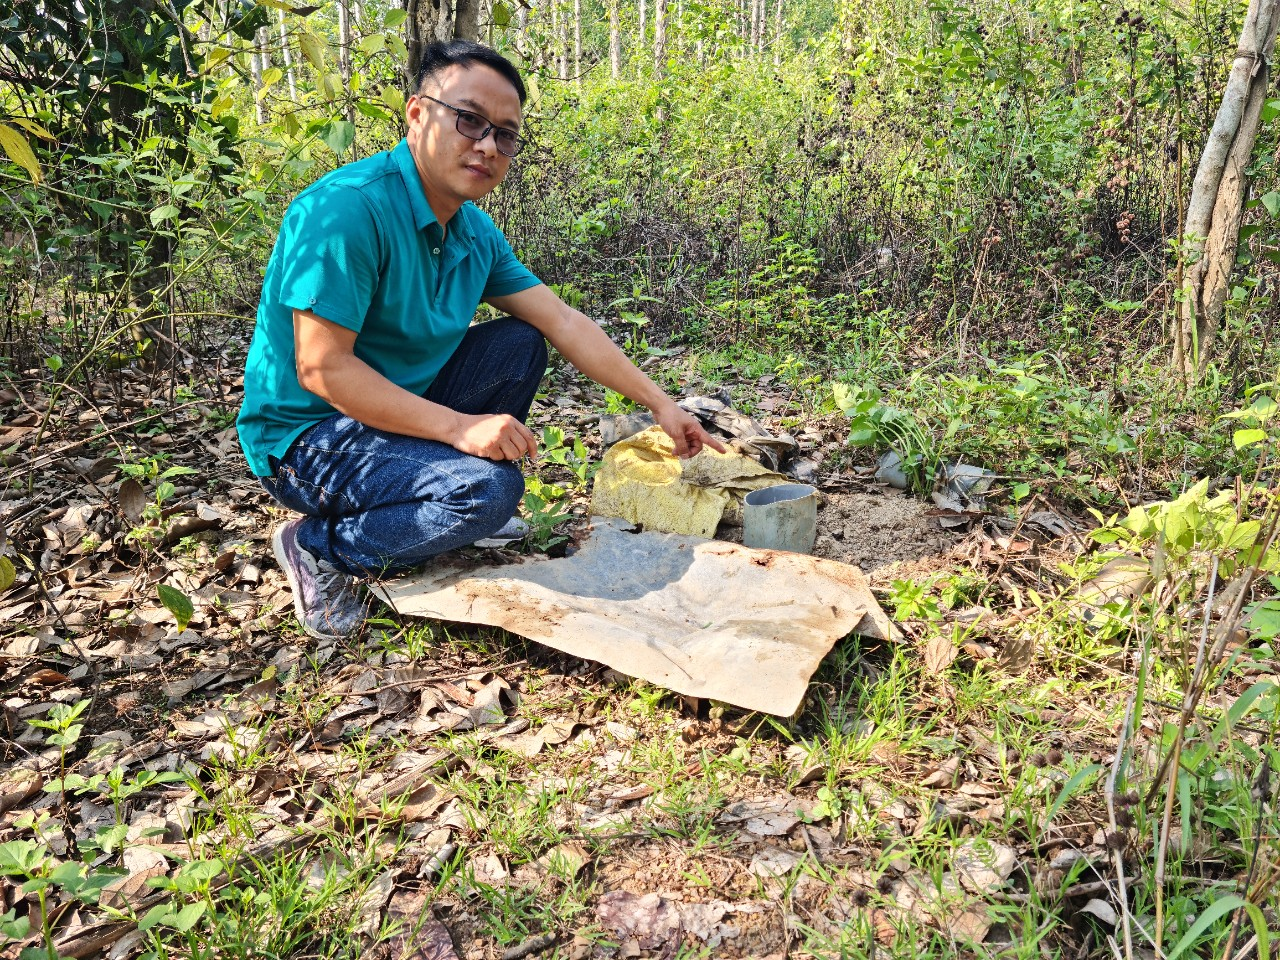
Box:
(404, 64), (520, 216)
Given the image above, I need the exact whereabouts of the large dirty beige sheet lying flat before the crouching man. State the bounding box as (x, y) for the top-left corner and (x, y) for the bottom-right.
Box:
(379, 517), (893, 717)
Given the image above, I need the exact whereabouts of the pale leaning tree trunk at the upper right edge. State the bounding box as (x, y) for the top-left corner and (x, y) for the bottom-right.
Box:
(1174, 0), (1280, 384)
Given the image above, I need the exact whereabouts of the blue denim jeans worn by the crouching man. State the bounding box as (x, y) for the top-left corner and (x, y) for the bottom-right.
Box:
(262, 316), (547, 576)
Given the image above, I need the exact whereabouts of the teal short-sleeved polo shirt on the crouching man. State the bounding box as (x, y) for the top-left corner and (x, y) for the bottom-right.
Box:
(236, 140), (539, 476)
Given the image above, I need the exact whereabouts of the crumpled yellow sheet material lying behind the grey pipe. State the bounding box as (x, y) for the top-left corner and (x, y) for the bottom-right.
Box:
(591, 426), (788, 538)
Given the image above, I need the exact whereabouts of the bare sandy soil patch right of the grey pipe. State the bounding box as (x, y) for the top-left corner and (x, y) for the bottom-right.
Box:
(813, 488), (961, 580)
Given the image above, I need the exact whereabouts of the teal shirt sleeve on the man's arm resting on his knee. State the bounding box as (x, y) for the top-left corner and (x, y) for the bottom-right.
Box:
(279, 186), (381, 333)
